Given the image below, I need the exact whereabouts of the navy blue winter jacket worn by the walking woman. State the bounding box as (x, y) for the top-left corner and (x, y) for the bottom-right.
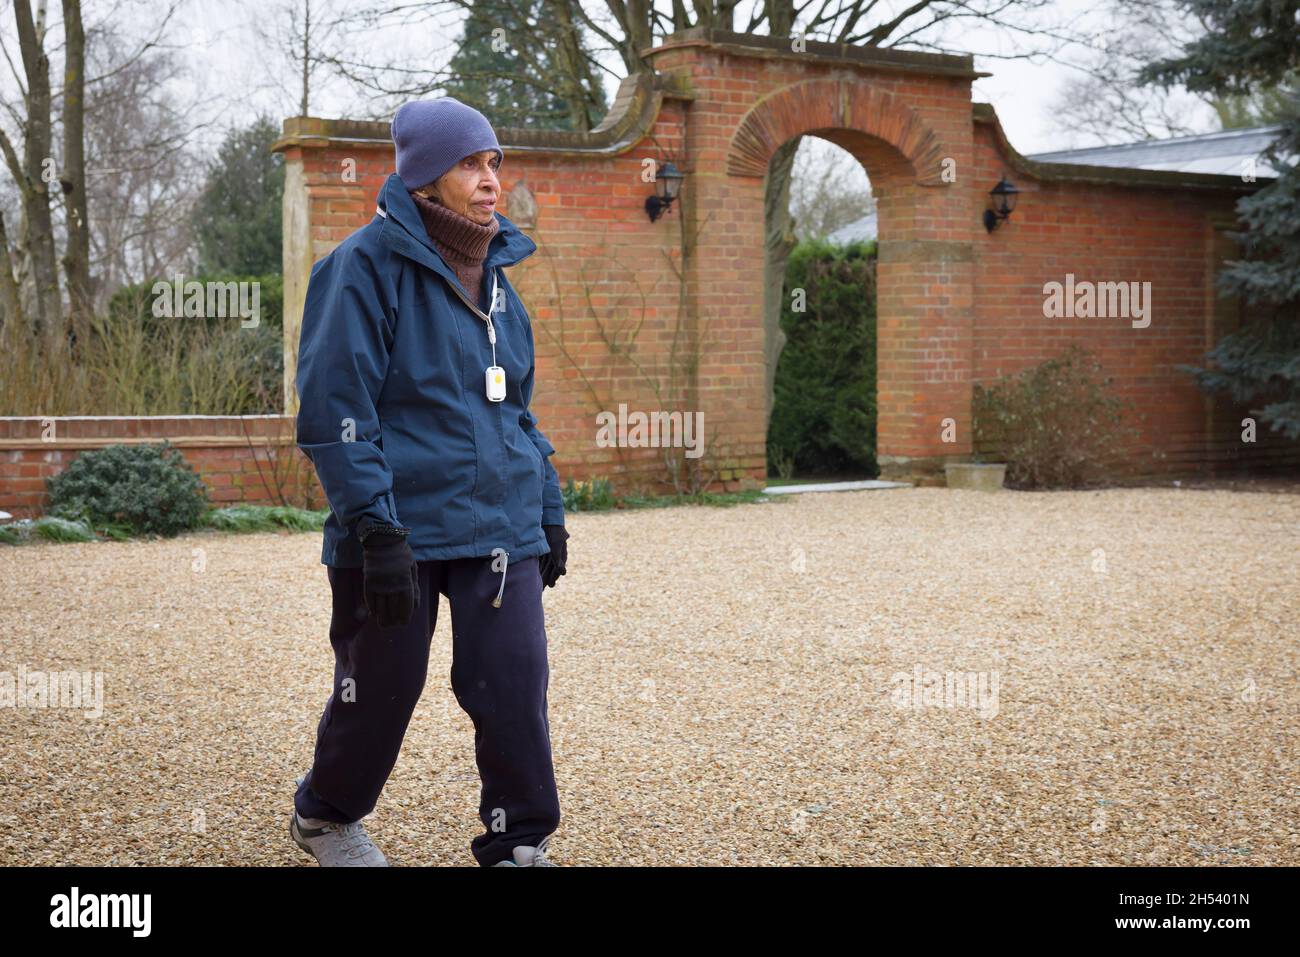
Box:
(296, 173), (564, 567)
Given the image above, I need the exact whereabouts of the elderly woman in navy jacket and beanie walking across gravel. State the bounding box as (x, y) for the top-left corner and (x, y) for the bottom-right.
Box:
(290, 98), (568, 866)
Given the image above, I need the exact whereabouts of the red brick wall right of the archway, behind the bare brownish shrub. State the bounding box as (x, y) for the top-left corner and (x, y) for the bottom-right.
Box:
(971, 124), (1300, 473)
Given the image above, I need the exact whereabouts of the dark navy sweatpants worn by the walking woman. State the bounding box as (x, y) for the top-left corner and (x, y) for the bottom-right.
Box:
(294, 558), (560, 867)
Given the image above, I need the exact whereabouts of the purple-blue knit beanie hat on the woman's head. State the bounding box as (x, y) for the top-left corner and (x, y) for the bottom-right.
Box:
(391, 96), (506, 190)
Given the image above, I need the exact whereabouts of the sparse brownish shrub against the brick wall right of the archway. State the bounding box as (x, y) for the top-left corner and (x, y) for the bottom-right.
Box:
(974, 346), (1131, 489)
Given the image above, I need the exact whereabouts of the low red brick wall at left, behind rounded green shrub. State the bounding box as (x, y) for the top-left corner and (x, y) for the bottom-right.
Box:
(0, 415), (325, 518)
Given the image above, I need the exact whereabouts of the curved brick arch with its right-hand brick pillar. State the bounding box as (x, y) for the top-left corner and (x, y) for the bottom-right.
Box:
(727, 72), (974, 479)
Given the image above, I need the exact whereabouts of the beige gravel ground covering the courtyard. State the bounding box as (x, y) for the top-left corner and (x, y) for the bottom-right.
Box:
(0, 489), (1300, 866)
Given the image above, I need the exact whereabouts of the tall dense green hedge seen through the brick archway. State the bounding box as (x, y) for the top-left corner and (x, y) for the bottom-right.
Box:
(767, 241), (879, 479)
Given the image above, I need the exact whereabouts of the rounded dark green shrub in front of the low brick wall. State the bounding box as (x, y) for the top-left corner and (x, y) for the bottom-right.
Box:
(48, 442), (208, 537)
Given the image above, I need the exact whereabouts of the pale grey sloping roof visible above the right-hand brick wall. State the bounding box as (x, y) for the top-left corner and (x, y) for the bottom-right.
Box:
(1028, 125), (1282, 177)
